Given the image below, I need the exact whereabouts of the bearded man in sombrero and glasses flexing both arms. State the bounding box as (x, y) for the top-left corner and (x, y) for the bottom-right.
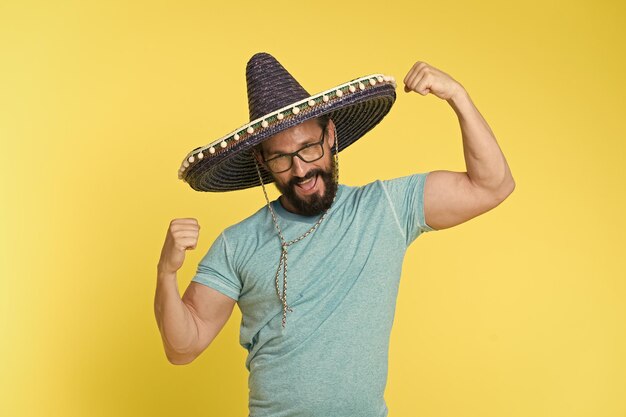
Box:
(155, 54), (514, 417)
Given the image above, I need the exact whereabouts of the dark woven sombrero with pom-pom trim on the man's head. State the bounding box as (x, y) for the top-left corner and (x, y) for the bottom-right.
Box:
(178, 52), (396, 191)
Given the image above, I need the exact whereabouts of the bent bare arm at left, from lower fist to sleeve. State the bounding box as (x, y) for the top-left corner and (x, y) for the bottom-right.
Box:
(154, 219), (236, 365)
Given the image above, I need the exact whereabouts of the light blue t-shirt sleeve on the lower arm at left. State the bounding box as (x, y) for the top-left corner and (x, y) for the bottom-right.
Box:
(191, 232), (242, 301)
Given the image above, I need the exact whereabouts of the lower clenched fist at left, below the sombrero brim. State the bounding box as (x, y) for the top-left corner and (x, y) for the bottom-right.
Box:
(158, 218), (200, 273)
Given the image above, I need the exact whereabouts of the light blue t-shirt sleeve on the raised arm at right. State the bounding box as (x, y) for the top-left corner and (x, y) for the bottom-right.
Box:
(381, 172), (435, 246)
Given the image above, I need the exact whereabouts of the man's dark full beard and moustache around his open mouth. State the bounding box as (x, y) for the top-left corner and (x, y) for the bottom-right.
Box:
(275, 158), (337, 216)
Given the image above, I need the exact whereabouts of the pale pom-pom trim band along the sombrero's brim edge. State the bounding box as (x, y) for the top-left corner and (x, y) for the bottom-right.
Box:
(178, 74), (396, 180)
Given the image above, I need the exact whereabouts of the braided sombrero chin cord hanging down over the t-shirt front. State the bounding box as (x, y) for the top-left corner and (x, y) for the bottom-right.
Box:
(254, 129), (339, 328)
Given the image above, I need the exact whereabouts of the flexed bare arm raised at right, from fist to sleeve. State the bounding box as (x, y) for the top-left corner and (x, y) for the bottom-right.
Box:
(404, 61), (515, 230)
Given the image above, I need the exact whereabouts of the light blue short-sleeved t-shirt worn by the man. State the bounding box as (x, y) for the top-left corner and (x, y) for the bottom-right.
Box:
(193, 173), (433, 417)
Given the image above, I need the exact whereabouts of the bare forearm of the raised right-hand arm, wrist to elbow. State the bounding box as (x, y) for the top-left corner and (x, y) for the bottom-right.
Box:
(447, 88), (514, 194)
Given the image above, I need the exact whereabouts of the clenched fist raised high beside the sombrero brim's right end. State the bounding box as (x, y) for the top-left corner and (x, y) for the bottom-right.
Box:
(404, 61), (463, 100)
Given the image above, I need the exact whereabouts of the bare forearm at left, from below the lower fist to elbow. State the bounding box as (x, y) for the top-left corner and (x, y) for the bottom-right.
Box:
(154, 271), (198, 362)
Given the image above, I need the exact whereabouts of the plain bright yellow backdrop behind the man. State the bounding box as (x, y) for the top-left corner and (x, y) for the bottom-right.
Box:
(0, 0), (626, 417)
